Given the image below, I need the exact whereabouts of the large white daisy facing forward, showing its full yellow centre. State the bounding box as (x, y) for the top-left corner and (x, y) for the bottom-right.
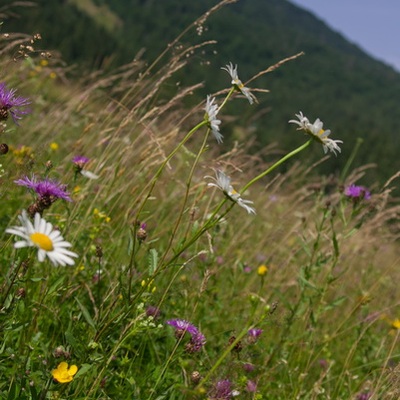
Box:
(6, 210), (78, 266)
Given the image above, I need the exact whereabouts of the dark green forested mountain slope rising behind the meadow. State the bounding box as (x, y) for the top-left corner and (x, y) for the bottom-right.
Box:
(4, 0), (400, 184)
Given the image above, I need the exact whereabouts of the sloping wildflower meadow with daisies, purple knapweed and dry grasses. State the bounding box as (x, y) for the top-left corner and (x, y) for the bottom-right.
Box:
(0, 1), (400, 400)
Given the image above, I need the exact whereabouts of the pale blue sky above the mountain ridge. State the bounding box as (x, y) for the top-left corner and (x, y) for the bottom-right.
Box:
(289, 0), (400, 72)
